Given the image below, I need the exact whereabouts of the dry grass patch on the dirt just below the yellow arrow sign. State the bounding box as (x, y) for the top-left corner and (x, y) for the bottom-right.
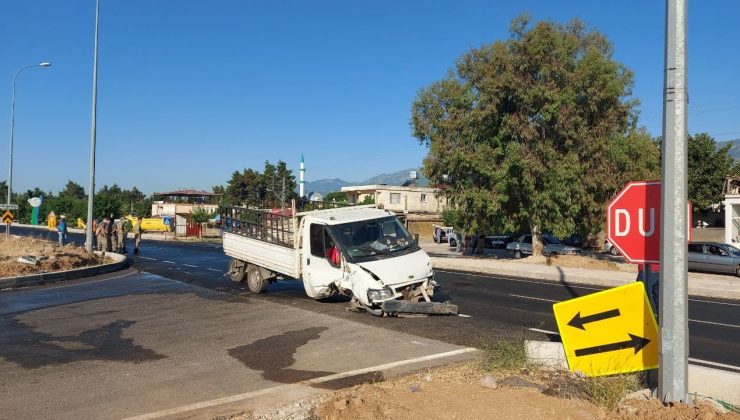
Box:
(543, 372), (643, 411)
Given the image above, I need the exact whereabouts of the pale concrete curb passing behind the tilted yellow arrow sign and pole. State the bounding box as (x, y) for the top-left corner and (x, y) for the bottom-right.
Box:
(526, 341), (740, 404)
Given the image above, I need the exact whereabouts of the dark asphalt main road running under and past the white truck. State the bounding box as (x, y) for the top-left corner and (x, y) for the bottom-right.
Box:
(5, 228), (740, 372)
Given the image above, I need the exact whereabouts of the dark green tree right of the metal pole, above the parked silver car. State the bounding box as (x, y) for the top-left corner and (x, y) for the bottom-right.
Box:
(688, 133), (734, 210)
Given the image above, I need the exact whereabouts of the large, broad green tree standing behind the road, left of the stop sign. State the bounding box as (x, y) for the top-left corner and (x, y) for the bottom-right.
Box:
(411, 15), (657, 253)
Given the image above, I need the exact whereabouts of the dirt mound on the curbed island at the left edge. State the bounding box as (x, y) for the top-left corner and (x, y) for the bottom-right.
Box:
(0, 236), (106, 277)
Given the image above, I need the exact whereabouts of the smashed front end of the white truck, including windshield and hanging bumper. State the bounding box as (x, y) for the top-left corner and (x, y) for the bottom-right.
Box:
(329, 215), (457, 316)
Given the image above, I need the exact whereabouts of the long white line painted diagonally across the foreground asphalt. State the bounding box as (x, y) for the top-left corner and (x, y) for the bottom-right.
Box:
(126, 347), (478, 420)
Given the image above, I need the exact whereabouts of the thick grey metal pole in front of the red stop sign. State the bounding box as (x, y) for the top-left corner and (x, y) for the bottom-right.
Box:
(658, 0), (690, 402)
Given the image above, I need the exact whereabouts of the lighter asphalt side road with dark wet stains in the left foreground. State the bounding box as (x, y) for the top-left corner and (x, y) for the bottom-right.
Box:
(0, 256), (472, 419)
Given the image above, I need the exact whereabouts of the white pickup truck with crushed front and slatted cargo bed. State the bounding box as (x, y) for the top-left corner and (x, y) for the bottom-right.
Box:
(221, 205), (457, 316)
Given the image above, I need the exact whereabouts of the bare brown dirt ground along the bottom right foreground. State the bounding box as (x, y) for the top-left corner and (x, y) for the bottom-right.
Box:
(313, 365), (740, 420)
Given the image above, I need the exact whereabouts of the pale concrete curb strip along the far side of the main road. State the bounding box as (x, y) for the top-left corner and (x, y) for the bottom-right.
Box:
(431, 257), (740, 300)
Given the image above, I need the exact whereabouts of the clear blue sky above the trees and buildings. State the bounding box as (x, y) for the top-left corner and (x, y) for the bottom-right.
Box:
(0, 0), (740, 193)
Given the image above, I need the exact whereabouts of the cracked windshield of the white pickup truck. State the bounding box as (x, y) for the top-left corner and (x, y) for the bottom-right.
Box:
(329, 217), (419, 261)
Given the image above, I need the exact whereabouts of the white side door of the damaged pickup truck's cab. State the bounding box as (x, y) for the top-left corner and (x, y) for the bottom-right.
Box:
(303, 223), (343, 298)
